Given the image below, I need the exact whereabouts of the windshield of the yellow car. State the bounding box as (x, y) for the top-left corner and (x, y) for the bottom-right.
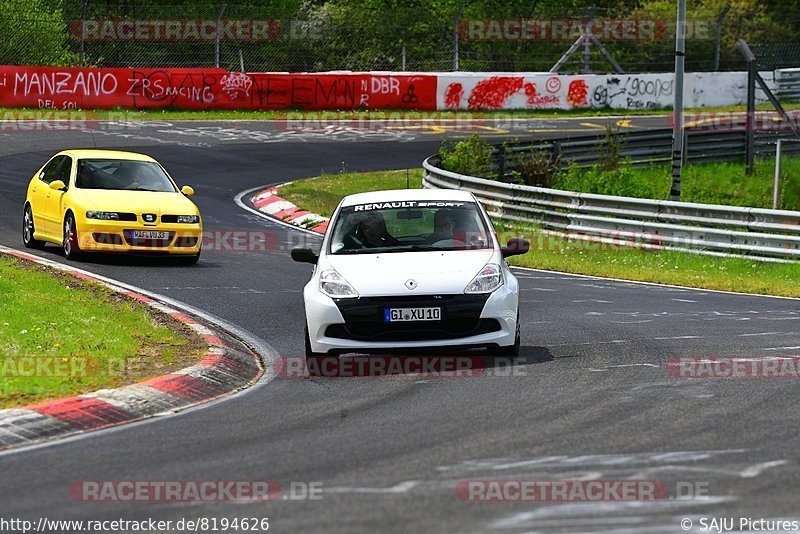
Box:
(75, 159), (177, 193)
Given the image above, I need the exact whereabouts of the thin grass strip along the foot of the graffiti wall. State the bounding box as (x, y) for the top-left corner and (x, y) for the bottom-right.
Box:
(0, 102), (800, 121)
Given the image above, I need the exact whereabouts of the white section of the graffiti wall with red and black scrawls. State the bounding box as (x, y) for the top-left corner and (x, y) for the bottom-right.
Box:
(437, 72), (771, 110)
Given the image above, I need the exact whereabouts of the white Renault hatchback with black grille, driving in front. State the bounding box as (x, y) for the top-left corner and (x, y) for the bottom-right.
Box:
(292, 189), (530, 357)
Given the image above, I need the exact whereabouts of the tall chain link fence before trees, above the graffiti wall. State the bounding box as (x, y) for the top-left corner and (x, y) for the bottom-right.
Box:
(0, 0), (800, 74)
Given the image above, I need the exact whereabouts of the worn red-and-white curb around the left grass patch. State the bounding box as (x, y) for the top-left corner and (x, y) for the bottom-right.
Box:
(0, 245), (264, 451)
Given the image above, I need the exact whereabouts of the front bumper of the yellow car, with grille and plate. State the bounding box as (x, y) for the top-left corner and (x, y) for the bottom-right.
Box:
(77, 218), (203, 255)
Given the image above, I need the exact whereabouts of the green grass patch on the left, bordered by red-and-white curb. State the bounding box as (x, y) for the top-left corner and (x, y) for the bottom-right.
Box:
(0, 255), (206, 408)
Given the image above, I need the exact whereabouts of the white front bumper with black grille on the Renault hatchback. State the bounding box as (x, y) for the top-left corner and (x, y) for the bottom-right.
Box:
(304, 277), (519, 353)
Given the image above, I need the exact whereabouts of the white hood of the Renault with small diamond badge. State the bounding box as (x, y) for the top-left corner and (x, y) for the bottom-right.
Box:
(326, 249), (495, 297)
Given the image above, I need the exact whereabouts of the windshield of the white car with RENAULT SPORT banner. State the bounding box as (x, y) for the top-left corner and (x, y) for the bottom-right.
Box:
(329, 200), (491, 254)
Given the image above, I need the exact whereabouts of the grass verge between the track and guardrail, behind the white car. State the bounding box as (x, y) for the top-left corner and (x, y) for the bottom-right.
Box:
(280, 169), (800, 297)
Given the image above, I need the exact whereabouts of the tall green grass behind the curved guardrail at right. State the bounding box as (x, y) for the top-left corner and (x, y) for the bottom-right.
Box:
(553, 156), (800, 210)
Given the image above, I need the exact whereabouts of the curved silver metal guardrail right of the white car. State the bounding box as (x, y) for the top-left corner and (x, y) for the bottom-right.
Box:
(423, 133), (800, 261)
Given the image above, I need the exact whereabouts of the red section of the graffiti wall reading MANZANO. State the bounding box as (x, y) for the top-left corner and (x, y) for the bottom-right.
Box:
(0, 66), (436, 110)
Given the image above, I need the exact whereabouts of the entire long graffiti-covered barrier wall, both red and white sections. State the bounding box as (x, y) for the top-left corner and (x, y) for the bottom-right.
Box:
(0, 66), (774, 110)
